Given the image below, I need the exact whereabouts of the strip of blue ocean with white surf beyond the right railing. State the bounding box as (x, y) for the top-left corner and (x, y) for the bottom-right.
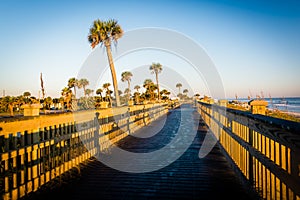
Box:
(228, 97), (300, 115)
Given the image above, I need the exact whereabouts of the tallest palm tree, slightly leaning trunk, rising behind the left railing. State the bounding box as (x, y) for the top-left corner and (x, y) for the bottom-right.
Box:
(88, 19), (123, 106)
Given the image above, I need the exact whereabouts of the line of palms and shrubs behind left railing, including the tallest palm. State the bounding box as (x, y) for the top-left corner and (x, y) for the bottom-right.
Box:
(0, 19), (192, 115)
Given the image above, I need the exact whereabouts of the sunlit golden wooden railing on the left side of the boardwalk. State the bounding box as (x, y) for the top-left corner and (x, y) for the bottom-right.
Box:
(0, 104), (168, 199)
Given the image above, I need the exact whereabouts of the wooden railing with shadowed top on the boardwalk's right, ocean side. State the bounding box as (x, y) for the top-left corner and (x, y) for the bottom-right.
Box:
(197, 102), (300, 199)
